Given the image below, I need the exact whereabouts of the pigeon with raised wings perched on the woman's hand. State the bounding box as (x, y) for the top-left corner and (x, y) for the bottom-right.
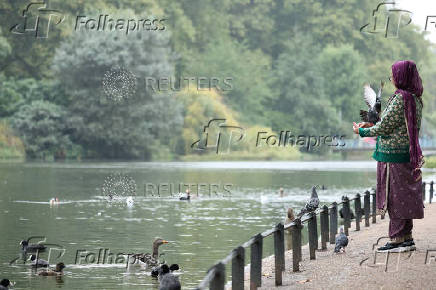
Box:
(360, 81), (385, 124)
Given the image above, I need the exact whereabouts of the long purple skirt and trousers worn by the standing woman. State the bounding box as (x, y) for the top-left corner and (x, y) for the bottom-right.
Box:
(376, 162), (424, 238)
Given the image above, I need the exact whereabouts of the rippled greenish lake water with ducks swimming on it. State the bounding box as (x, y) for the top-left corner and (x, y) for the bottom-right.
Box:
(0, 162), (429, 289)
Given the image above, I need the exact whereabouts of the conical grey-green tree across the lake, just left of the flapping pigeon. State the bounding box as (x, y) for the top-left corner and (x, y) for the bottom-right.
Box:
(267, 35), (341, 134)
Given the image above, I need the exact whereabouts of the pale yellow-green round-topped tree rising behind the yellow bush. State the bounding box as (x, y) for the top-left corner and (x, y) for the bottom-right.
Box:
(188, 39), (271, 123)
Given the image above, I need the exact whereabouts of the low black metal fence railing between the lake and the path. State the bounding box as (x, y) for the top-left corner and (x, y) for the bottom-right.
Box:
(196, 181), (434, 290)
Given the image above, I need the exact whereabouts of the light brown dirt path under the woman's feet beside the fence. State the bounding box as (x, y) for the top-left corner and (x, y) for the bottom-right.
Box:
(245, 204), (436, 289)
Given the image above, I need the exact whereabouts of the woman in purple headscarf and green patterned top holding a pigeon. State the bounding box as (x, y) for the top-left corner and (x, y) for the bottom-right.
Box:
(353, 60), (424, 251)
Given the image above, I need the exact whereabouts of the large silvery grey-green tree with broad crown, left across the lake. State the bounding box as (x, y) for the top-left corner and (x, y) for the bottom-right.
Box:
(53, 11), (182, 159)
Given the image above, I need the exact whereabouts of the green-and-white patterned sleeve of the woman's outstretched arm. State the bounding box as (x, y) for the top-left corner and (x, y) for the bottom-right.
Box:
(359, 94), (404, 137)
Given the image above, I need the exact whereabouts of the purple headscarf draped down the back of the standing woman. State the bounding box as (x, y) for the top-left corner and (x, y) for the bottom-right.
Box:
(392, 60), (424, 180)
